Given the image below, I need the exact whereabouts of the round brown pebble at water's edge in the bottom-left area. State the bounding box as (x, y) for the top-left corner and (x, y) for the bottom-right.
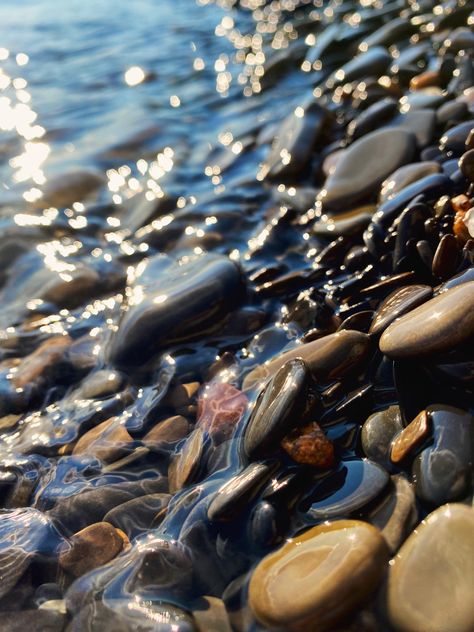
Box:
(59, 522), (124, 577)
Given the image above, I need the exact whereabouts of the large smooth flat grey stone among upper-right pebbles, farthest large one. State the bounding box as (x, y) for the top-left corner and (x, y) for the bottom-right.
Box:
(319, 129), (416, 211)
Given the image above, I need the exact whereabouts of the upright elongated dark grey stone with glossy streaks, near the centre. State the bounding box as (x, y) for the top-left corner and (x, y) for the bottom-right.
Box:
(244, 359), (309, 458)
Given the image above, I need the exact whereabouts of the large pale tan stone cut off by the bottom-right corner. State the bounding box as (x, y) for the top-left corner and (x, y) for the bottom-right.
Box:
(387, 504), (474, 632)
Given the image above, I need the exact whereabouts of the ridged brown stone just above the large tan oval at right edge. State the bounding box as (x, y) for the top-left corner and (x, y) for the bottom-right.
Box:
(369, 285), (433, 336)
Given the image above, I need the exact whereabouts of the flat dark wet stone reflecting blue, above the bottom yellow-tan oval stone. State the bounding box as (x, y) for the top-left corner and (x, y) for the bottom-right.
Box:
(308, 459), (389, 520)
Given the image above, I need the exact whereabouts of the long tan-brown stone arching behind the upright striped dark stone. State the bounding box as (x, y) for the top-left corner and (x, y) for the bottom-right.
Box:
(243, 330), (370, 388)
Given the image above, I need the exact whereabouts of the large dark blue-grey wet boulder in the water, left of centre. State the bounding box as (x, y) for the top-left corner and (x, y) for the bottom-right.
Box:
(107, 254), (244, 367)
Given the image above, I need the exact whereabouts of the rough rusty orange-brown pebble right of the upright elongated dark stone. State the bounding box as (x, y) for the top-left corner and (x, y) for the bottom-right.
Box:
(281, 421), (334, 468)
